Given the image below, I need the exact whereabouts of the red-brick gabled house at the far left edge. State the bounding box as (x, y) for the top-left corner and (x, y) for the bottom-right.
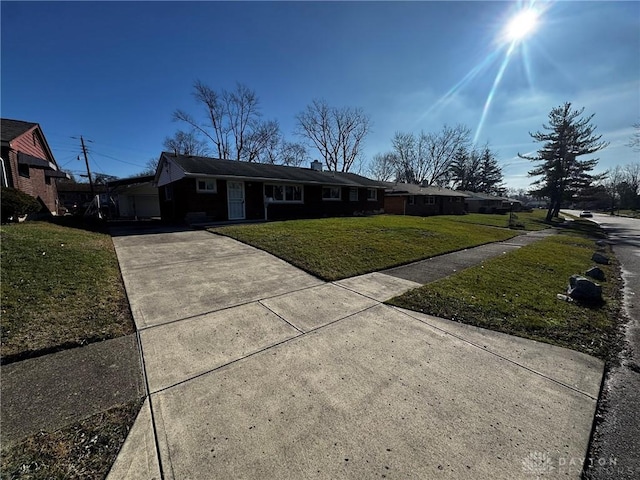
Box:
(0, 118), (69, 215)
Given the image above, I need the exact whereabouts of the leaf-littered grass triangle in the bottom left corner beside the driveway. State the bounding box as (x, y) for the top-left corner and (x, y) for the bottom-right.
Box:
(0, 400), (142, 480)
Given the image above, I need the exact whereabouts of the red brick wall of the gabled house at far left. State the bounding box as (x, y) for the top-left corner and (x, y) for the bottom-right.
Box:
(2, 128), (58, 215)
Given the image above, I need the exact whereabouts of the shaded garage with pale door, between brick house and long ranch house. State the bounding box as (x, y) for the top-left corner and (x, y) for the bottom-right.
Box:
(108, 175), (160, 219)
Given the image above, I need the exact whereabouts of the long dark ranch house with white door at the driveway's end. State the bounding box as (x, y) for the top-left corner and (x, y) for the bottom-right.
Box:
(155, 152), (384, 223)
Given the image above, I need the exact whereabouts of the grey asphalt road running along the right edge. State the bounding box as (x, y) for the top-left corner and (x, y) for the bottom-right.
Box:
(567, 210), (640, 480)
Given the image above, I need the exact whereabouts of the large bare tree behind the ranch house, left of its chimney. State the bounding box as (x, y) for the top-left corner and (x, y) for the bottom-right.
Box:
(173, 80), (279, 161)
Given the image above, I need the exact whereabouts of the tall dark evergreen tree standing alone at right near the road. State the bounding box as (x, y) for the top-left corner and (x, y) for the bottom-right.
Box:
(518, 102), (608, 221)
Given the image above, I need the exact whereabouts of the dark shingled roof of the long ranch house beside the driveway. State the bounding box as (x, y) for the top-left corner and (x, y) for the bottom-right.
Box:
(162, 152), (384, 188)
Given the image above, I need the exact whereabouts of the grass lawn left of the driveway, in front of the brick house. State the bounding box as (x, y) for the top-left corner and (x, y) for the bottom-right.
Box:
(0, 222), (135, 361)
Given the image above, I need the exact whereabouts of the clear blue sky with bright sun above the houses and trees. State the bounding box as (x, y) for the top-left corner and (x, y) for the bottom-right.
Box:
(0, 1), (640, 188)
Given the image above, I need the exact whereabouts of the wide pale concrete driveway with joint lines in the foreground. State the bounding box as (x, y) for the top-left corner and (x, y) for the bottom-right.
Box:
(109, 231), (603, 479)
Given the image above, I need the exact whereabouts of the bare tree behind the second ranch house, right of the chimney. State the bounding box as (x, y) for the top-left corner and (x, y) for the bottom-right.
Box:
(384, 125), (471, 186)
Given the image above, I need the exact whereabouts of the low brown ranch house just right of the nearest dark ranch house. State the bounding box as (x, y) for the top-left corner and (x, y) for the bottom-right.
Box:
(384, 182), (466, 216)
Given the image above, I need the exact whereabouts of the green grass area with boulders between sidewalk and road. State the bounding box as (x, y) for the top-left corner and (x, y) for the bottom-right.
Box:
(389, 235), (619, 358)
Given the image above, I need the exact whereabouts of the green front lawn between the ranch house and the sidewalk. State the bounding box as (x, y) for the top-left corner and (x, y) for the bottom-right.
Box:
(211, 215), (517, 281)
